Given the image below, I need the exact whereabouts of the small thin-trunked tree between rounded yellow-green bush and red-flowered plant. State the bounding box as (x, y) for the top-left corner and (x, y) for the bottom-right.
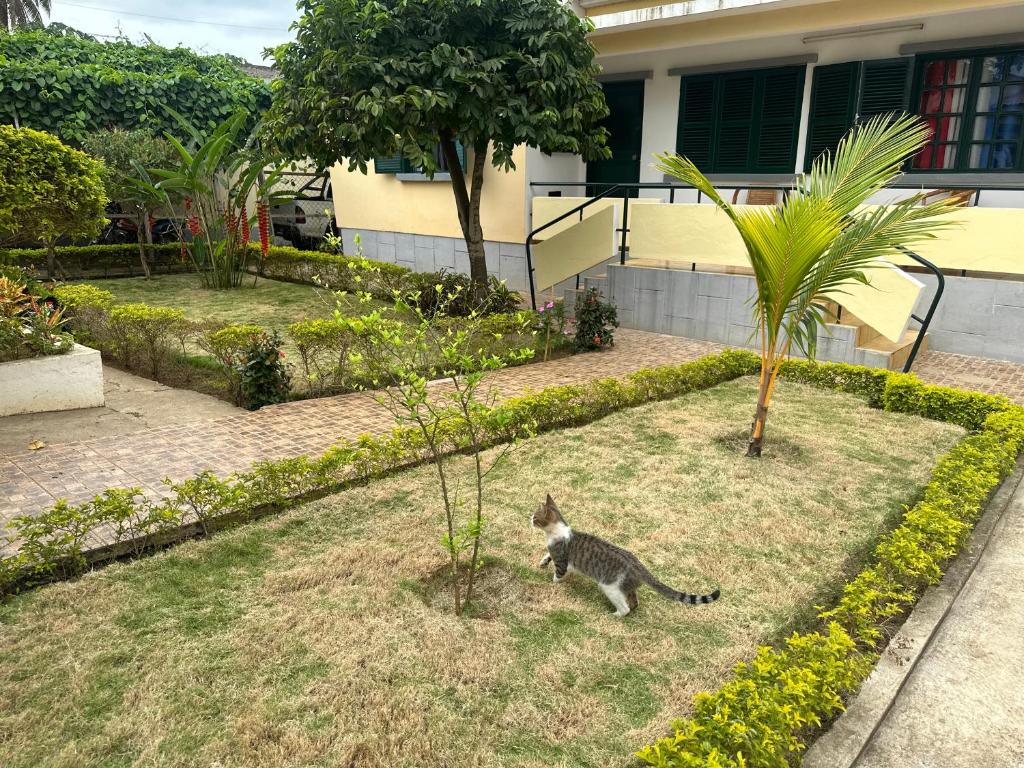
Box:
(82, 129), (177, 278)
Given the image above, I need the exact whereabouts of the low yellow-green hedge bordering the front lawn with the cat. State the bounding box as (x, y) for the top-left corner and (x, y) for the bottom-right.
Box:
(0, 350), (1024, 768)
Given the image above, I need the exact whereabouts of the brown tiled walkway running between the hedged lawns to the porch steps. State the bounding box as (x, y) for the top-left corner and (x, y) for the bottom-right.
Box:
(0, 330), (1024, 552)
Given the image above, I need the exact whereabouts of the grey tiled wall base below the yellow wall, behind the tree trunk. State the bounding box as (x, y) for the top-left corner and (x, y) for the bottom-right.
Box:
(341, 227), (529, 291)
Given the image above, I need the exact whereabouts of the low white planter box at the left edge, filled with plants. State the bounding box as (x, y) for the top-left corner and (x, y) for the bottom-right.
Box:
(0, 344), (103, 416)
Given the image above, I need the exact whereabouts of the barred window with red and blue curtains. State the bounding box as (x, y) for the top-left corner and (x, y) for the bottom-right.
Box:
(912, 50), (1024, 172)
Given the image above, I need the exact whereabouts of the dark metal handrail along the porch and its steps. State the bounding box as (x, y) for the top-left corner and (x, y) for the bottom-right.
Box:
(526, 181), (946, 373)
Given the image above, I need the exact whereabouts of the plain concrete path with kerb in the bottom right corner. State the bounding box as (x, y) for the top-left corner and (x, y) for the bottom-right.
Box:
(804, 467), (1024, 768)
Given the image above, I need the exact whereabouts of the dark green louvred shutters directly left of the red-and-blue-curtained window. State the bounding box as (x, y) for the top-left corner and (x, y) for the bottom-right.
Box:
(805, 58), (910, 170)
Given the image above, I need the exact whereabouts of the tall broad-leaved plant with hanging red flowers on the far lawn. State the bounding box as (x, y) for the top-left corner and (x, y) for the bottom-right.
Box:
(135, 112), (294, 289)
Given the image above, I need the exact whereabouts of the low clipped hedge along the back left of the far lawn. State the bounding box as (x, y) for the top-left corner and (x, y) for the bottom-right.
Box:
(0, 243), (193, 280)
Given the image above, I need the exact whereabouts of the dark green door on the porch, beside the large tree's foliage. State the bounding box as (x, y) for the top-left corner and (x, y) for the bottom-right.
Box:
(587, 80), (643, 198)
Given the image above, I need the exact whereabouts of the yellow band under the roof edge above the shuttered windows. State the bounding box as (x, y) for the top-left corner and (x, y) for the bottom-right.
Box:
(590, 0), (1011, 56)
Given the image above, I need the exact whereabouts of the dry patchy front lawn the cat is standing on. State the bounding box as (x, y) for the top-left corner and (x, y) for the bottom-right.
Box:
(0, 379), (963, 768)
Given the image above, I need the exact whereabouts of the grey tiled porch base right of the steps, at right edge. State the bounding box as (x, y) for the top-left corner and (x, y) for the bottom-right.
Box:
(913, 274), (1024, 362)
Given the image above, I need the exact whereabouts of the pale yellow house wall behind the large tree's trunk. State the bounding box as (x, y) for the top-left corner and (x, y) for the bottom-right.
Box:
(331, 147), (526, 243)
